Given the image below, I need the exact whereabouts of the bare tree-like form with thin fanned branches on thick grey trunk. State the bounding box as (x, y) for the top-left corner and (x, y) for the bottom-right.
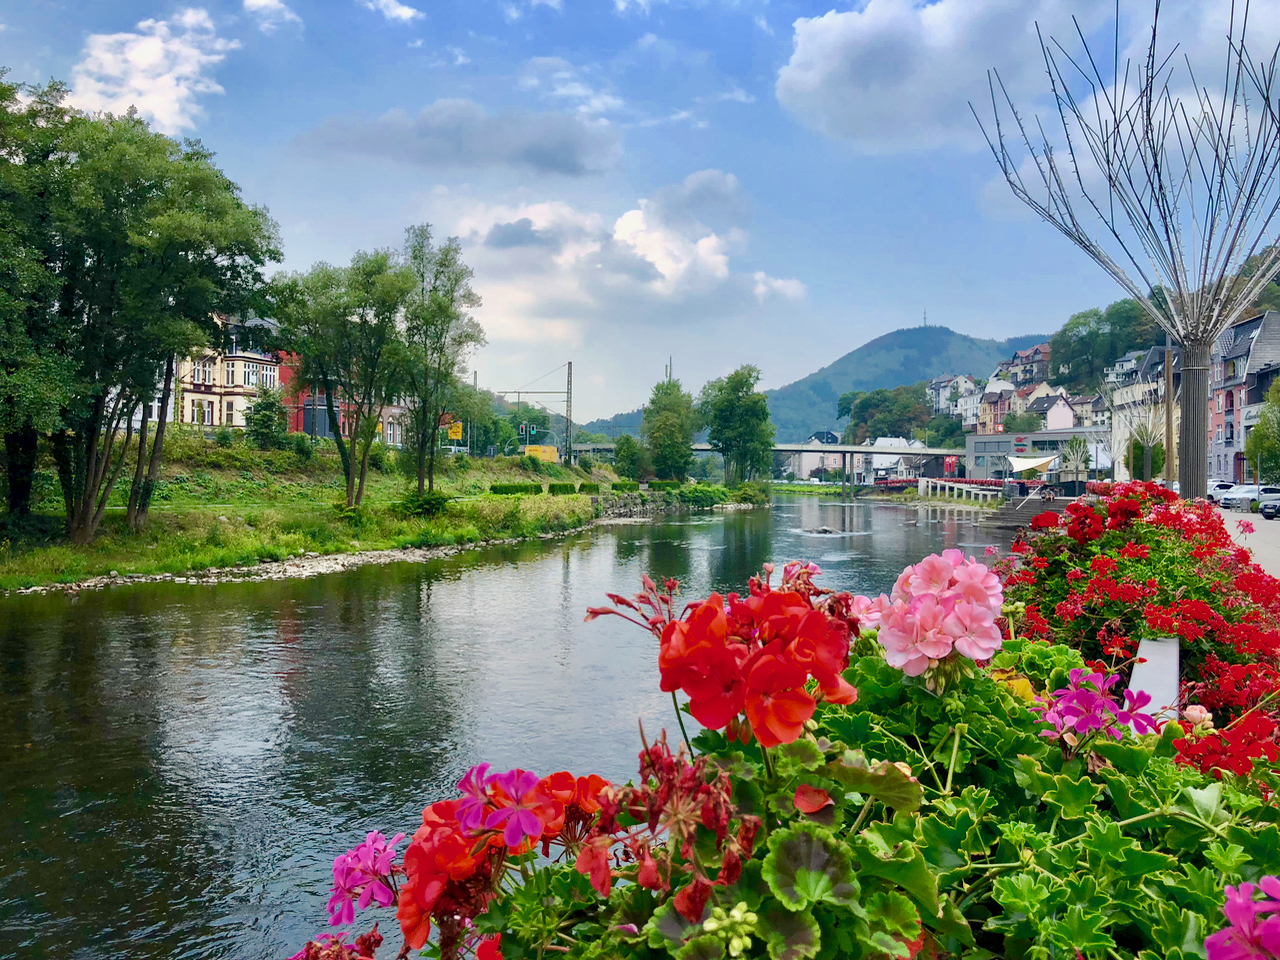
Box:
(970, 0), (1280, 497)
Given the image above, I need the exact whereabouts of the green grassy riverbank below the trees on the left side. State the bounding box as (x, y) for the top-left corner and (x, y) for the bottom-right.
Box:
(0, 436), (614, 590)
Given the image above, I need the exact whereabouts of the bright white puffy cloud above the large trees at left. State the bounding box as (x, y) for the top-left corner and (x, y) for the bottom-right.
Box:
(72, 8), (239, 134)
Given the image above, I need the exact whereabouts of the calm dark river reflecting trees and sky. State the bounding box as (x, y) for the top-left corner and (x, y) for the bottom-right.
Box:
(0, 497), (989, 960)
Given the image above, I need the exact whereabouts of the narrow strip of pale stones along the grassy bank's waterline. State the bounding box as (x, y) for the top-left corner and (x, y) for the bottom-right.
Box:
(6, 494), (751, 594)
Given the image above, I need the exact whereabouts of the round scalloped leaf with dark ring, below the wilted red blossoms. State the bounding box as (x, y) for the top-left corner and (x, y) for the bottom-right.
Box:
(762, 823), (861, 913)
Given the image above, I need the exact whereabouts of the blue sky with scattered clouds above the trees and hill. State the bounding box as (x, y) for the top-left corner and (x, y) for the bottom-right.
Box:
(0, 0), (1254, 420)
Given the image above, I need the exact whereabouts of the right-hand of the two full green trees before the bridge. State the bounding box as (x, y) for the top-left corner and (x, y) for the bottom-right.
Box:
(698, 364), (773, 484)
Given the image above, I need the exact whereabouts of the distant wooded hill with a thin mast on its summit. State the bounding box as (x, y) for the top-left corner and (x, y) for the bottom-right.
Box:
(765, 326), (1050, 443)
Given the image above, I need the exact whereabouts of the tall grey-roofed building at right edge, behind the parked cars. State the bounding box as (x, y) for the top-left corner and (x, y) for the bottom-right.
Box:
(1208, 310), (1280, 483)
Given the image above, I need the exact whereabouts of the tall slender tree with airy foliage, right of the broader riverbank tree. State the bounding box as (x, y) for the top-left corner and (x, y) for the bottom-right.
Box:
(404, 224), (485, 493)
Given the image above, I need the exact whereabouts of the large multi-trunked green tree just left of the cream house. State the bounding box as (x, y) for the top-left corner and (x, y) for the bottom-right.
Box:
(40, 114), (279, 543)
